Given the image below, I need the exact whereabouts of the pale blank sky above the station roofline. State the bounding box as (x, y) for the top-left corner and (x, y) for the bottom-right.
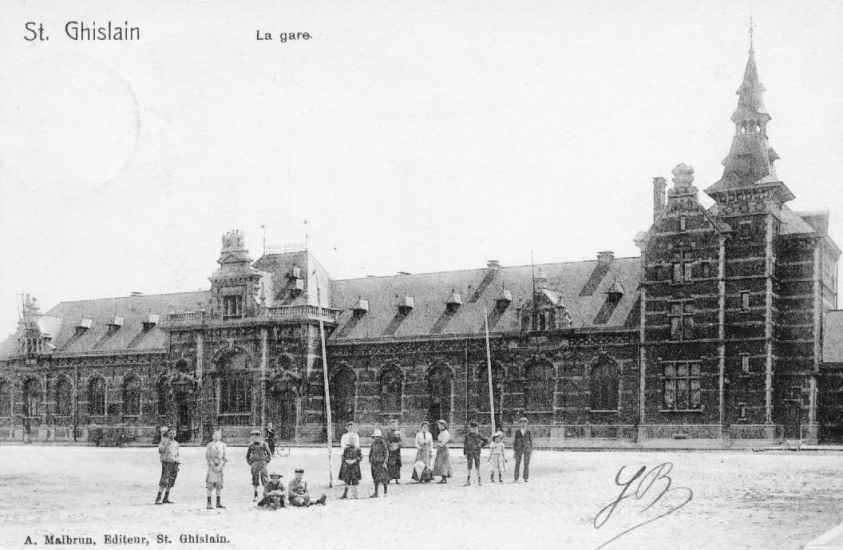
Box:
(0, 0), (843, 335)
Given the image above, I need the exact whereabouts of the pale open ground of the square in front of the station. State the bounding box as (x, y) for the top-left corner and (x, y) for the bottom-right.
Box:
(0, 445), (843, 550)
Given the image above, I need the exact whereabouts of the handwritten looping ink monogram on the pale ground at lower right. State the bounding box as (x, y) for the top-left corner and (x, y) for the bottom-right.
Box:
(594, 462), (694, 550)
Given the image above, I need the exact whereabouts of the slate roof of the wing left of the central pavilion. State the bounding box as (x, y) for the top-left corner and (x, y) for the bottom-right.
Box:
(0, 291), (208, 359)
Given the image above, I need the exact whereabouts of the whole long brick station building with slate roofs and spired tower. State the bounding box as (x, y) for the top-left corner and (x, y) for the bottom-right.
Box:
(0, 46), (843, 447)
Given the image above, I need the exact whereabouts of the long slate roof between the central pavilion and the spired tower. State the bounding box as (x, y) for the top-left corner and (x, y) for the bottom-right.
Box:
(331, 258), (641, 342)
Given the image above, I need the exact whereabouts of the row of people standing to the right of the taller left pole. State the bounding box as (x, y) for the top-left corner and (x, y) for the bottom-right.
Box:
(339, 417), (533, 499)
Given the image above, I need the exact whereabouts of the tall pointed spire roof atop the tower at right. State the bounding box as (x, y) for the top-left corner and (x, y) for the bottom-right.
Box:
(706, 25), (793, 202)
